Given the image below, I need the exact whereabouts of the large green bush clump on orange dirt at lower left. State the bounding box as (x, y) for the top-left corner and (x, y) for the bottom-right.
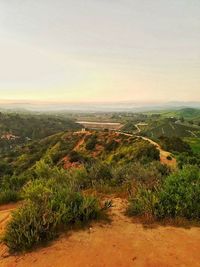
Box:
(4, 179), (101, 251)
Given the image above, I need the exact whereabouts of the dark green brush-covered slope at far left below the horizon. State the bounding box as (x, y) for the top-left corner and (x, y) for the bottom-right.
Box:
(0, 113), (81, 153)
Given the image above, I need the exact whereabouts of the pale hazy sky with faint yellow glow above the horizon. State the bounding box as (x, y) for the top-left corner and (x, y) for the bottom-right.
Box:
(0, 0), (200, 102)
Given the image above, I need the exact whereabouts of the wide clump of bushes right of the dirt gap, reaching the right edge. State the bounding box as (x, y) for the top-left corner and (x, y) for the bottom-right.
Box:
(128, 165), (200, 219)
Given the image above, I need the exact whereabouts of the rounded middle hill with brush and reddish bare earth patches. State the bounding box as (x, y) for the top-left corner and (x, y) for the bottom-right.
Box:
(0, 131), (159, 178)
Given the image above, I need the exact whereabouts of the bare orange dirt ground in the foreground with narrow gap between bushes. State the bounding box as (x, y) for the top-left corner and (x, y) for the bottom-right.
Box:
(0, 198), (200, 267)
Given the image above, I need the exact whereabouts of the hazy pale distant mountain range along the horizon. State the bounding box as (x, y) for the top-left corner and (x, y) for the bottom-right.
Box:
(0, 101), (200, 112)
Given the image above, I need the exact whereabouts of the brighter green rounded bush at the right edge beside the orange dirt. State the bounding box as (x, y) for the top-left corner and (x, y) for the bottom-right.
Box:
(156, 165), (200, 219)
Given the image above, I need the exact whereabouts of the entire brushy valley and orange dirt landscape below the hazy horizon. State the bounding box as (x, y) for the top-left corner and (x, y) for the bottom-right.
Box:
(0, 108), (200, 267)
